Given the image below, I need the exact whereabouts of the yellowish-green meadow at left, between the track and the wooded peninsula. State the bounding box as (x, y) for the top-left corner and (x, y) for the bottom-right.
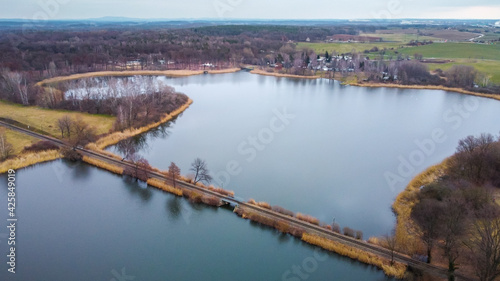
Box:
(0, 101), (115, 137)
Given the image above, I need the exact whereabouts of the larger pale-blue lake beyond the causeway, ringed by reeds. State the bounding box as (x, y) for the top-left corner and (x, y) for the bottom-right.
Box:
(111, 72), (500, 238)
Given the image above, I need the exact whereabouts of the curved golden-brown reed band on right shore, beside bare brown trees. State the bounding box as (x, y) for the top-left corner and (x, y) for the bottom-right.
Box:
(392, 158), (449, 255)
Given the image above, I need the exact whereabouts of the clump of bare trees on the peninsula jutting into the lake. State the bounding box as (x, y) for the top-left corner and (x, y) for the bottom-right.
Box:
(55, 76), (188, 130)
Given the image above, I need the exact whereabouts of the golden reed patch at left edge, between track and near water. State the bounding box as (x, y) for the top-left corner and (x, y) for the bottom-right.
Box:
(0, 150), (62, 174)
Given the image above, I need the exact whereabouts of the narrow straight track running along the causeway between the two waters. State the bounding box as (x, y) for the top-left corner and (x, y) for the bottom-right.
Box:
(0, 121), (474, 280)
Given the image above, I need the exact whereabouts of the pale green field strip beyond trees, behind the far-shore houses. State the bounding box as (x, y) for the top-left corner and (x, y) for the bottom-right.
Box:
(296, 42), (403, 54)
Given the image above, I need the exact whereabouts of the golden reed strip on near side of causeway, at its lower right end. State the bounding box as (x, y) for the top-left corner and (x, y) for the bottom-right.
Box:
(302, 233), (406, 279)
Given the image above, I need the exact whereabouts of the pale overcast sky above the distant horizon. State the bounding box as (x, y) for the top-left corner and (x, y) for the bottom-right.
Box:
(0, 0), (500, 20)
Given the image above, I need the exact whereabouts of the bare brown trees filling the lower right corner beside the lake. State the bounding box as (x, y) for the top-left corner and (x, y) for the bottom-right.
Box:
(411, 134), (500, 280)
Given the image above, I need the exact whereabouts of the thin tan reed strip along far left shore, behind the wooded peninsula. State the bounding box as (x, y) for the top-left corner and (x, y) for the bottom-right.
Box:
(36, 67), (241, 86)
